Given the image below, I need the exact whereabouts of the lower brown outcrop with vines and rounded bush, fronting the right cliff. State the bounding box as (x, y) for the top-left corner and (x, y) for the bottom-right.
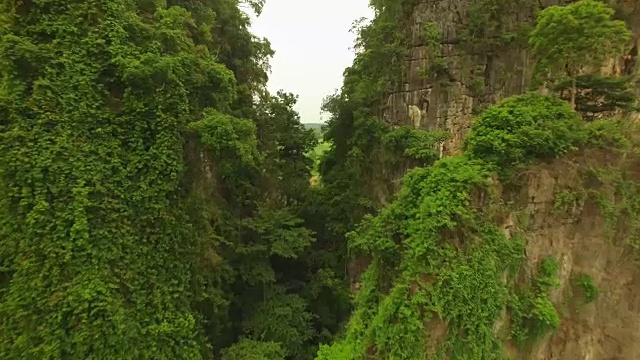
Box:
(319, 94), (640, 359)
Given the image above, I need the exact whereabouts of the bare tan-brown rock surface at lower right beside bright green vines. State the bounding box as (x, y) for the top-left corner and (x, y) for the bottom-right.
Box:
(502, 154), (640, 360)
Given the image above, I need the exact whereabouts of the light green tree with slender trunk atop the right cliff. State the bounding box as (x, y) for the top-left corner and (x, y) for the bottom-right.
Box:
(529, 0), (631, 109)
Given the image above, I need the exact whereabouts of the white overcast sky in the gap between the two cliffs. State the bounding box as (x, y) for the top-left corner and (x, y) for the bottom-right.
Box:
(251, 0), (373, 122)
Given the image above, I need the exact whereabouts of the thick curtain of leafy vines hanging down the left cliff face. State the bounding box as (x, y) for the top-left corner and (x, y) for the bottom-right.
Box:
(0, 1), (224, 359)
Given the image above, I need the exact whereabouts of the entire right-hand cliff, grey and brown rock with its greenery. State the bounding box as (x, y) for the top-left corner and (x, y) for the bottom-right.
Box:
(318, 0), (640, 360)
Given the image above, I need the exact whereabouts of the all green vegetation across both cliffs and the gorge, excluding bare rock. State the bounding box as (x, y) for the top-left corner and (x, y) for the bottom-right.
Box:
(0, 0), (640, 360)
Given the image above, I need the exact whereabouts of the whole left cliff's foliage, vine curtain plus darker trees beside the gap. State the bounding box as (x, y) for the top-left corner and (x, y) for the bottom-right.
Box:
(0, 0), (336, 359)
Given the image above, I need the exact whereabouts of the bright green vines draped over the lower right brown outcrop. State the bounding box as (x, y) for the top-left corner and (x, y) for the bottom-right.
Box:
(318, 156), (523, 359)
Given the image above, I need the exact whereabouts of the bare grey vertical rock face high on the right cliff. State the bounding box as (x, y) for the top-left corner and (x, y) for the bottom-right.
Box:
(383, 0), (640, 154)
